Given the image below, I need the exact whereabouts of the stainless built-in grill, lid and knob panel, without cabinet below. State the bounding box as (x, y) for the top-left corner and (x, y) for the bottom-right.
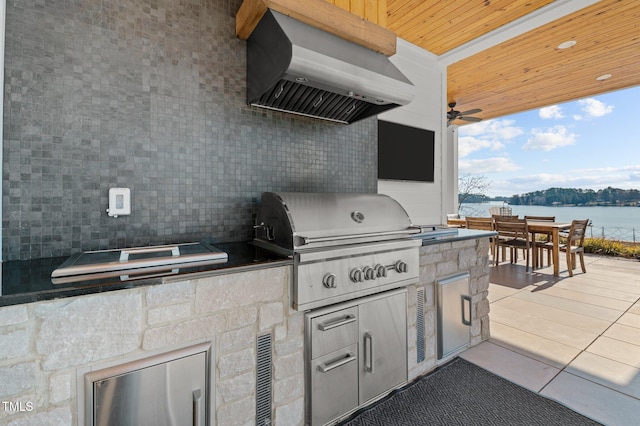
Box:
(255, 192), (421, 310)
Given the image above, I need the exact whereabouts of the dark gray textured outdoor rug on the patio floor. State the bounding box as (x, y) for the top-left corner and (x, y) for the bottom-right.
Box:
(341, 358), (600, 426)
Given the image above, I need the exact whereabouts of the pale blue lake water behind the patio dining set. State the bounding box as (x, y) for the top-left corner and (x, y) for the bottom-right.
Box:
(460, 202), (640, 241)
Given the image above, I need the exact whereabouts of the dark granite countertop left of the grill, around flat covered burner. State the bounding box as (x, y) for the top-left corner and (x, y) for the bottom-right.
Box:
(0, 242), (293, 306)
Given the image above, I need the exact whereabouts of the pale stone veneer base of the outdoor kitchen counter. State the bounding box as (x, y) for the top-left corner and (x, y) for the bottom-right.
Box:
(0, 238), (496, 426)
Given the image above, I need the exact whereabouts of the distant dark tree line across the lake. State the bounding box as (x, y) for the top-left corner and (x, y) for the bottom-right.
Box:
(508, 187), (640, 206)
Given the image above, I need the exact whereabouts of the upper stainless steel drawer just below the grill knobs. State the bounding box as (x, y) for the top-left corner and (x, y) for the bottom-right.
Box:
(310, 306), (358, 359)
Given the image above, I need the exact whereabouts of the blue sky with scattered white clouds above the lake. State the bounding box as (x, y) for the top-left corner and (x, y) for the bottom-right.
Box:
(458, 86), (640, 197)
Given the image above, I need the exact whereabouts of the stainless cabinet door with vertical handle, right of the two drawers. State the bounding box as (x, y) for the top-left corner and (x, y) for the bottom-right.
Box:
(359, 290), (407, 404)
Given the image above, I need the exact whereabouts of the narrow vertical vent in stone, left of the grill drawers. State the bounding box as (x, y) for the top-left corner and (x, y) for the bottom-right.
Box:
(256, 334), (272, 426)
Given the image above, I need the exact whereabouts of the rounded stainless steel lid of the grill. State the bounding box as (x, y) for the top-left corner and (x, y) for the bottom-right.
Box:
(257, 192), (419, 250)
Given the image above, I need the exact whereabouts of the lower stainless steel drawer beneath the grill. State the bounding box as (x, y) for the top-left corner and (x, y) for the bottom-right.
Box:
(310, 344), (358, 425)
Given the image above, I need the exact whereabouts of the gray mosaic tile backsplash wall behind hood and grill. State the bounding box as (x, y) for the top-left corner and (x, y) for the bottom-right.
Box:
(2, 0), (377, 260)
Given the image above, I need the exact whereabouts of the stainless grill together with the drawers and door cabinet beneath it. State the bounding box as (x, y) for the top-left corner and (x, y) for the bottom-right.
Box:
(255, 192), (421, 426)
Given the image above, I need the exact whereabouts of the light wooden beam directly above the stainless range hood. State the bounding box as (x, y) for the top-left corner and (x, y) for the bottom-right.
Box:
(236, 0), (396, 56)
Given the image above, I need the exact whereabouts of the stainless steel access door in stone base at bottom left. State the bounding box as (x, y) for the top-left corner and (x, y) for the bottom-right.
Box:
(93, 352), (208, 426)
